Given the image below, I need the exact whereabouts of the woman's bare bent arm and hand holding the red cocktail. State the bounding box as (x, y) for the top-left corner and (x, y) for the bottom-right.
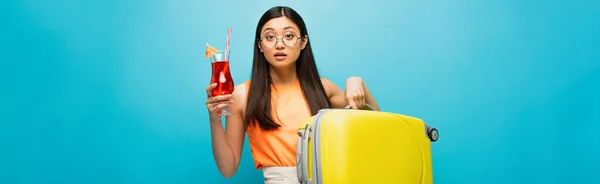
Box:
(207, 84), (246, 178)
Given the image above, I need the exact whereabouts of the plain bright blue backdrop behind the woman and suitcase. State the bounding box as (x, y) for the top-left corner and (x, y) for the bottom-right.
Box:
(0, 0), (600, 184)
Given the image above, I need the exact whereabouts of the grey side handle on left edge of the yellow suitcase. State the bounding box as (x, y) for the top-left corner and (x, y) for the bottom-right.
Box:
(296, 124), (310, 184)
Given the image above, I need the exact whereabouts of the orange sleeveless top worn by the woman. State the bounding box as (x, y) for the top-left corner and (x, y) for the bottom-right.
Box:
(246, 80), (311, 169)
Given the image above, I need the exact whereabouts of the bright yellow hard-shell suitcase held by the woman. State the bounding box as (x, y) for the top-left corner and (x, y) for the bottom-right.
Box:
(296, 105), (438, 184)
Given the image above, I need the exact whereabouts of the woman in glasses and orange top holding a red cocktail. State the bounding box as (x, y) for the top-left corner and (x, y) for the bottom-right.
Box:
(206, 6), (379, 183)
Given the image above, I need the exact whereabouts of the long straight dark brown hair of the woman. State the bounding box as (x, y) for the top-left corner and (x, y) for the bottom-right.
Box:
(244, 6), (331, 130)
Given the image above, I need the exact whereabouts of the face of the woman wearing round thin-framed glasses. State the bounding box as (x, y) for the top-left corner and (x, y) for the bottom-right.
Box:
(258, 17), (307, 68)
